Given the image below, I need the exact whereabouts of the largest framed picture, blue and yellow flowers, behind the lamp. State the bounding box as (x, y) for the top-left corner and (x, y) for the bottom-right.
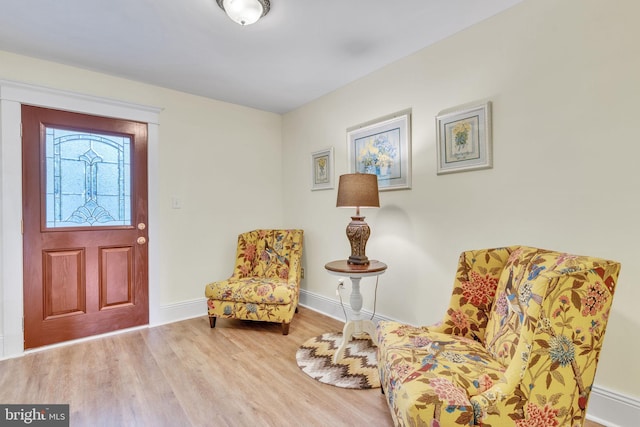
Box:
(347, 110), (411, 191)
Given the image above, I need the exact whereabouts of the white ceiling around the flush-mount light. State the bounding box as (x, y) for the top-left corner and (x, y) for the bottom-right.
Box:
(0, 0), (522, 113)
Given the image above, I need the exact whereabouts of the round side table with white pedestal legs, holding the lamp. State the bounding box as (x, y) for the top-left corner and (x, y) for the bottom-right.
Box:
(324, 259), (387, 363)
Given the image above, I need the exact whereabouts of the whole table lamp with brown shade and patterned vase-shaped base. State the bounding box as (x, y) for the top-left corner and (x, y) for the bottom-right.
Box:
(336, 173), (380, 265)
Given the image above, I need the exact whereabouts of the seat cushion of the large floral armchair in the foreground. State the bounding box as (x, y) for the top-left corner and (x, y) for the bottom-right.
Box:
(377, 321), (505, 425)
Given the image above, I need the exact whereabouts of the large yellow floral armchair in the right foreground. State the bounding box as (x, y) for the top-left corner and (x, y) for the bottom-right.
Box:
(376, 246), (620, 427)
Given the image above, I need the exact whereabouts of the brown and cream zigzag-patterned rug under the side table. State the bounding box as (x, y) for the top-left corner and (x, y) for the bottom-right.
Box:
(296, 332), (380, 389)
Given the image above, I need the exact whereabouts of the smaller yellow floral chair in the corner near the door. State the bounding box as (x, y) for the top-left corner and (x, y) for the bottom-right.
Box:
(205, 230), (304, 335)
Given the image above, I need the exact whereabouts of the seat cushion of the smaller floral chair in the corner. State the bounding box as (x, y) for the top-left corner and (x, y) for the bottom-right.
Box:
(205, 277), (296, 304)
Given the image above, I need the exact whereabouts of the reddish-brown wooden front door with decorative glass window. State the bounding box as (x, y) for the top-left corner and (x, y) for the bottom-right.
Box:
(22, 106), (149, 349)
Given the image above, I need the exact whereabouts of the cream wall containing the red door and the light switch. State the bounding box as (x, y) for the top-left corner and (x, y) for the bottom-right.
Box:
(0, 51), (283, 332)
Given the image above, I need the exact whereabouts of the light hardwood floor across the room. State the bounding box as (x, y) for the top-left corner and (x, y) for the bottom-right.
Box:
(0, 308), (599, 427)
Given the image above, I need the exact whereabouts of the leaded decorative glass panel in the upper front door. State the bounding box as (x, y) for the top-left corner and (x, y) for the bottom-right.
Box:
(46, 127), (131, 228)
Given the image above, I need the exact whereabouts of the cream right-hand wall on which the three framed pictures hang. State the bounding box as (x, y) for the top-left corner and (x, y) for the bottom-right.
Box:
(283, 0), (640, 406)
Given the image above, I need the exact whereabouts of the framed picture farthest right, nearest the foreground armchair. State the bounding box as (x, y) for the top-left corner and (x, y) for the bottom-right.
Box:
(436, 102), (493, 175)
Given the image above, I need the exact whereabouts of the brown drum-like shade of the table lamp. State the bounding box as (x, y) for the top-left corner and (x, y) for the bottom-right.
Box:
(336, 173), (380, 208)
